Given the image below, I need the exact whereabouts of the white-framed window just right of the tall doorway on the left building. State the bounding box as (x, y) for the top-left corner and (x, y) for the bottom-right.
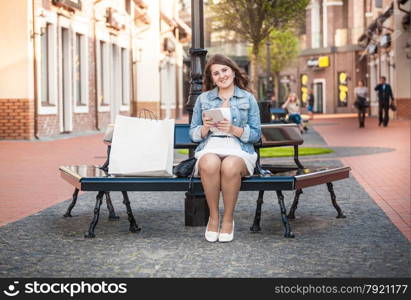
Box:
(73, 33), (88, 106)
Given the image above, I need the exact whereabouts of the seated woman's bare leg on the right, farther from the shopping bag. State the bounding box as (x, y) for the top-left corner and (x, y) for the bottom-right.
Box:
(220, 156), (248, 233)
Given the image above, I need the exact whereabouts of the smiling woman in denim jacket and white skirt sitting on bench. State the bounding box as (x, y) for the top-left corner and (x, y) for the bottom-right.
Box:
(190, 54), (261, 242)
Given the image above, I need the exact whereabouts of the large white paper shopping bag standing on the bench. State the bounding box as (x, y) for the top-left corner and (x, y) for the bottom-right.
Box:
(109, 115), (175, 177)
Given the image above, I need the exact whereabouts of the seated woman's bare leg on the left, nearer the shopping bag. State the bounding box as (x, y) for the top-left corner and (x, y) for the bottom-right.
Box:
(198, 153), (221, 232)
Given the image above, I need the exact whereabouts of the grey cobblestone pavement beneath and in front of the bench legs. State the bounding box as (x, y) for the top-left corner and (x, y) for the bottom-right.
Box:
(0, 126), (411, 278)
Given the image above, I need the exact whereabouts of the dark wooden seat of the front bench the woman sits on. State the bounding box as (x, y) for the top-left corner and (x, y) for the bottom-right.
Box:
(60, 165), (350, 192)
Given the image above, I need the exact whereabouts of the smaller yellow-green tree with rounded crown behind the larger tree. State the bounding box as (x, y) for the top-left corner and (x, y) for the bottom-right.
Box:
(259, 29), (299, 101)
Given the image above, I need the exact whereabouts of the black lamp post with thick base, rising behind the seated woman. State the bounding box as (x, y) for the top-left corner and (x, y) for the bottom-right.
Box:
(184, 0), (210, 226)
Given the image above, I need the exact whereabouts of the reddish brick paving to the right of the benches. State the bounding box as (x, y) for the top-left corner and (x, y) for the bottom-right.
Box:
(310, 115), (411, 241)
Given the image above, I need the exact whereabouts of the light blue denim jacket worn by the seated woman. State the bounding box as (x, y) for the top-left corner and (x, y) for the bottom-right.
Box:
(190, 86), (261, 153)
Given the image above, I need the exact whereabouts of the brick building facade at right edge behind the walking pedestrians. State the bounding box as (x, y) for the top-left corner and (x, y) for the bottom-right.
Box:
(358, 0), (411, 119)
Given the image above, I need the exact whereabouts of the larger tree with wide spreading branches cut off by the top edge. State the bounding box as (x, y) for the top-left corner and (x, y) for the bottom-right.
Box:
(211, 0), (309, 90)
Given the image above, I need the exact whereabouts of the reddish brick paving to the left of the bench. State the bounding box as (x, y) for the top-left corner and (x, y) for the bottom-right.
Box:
(0, 134), (106, 226)
